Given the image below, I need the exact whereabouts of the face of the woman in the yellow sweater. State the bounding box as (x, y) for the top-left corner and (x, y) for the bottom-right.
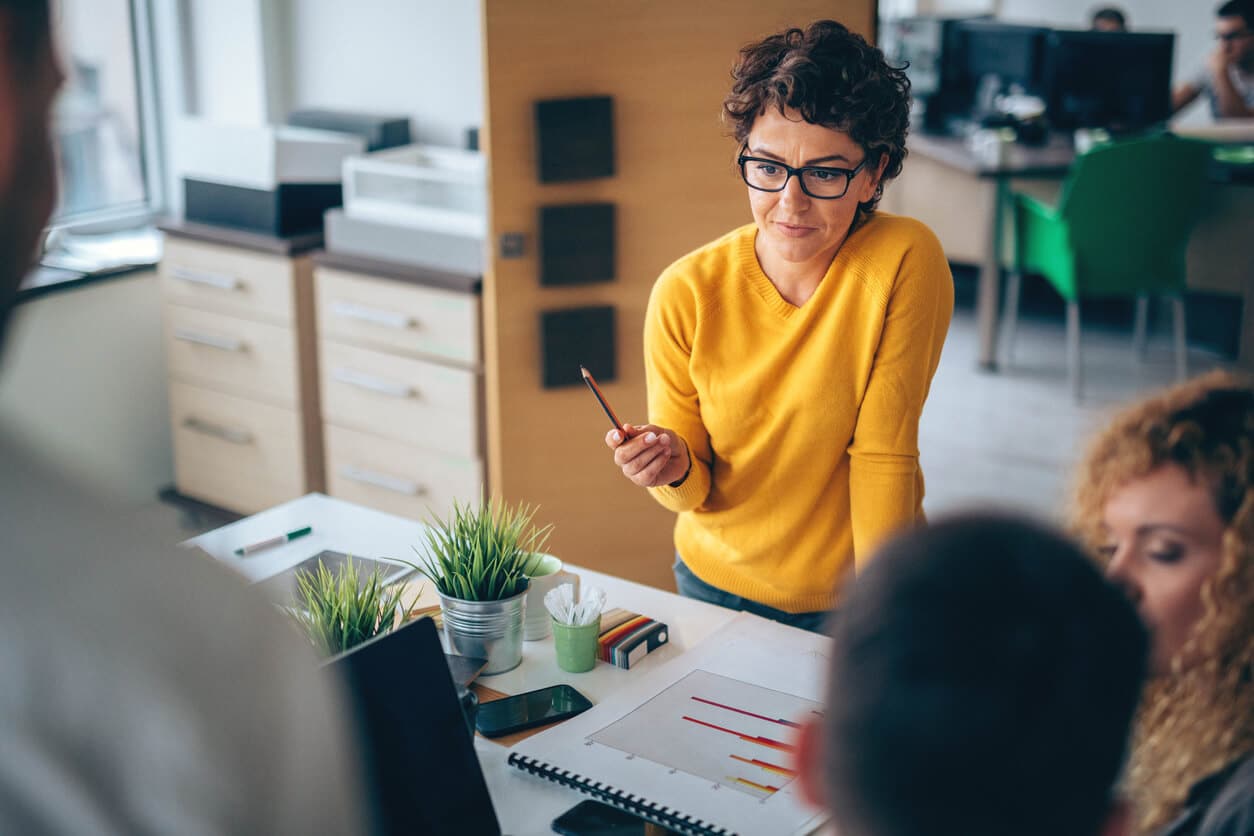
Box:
(744, 109), (883, 276)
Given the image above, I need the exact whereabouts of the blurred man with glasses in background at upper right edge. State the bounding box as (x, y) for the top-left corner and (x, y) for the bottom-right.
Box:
(1171, 0), (1254, 119)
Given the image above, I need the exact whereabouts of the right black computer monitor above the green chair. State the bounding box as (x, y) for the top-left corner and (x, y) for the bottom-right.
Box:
(1043, 30), (1175, 133)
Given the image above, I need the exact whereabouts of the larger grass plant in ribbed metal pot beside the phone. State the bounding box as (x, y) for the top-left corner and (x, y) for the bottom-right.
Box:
(414, 498), (552, 674)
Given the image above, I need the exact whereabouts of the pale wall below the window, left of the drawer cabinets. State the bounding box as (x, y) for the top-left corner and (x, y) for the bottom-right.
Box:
(0, 272), (174, 505)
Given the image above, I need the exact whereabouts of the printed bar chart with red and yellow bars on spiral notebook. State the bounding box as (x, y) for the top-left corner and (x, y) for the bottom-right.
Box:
(591, 671), (821, 798)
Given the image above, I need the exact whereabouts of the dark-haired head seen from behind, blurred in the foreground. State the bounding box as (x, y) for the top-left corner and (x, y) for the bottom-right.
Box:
(794, 514), (1149, 836)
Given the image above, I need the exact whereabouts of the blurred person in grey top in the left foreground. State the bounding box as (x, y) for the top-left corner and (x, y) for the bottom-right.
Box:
(0, 0), (364, 833)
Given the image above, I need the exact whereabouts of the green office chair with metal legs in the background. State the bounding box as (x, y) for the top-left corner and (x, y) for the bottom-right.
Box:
(1004, 135), (1211, 400)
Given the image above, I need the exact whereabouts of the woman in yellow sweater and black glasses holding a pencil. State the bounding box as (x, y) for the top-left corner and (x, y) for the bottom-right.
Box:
(606, 20), (953, 629)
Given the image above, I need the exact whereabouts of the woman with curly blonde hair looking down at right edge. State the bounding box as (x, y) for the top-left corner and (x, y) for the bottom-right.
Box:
(1075, 372), (1254, 836)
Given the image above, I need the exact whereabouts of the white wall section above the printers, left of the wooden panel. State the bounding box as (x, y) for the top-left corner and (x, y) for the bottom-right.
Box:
(287, 0), (483, 145)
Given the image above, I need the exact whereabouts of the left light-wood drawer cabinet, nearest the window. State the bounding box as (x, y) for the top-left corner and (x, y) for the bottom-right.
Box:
(161, 224), (324, 514)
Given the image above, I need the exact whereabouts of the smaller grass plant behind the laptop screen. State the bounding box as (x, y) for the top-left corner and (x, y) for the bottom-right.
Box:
(287, 556), (403, 657)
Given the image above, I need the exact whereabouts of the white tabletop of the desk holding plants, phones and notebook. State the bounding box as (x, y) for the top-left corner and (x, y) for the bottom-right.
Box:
(184, 494), (736, 836)
